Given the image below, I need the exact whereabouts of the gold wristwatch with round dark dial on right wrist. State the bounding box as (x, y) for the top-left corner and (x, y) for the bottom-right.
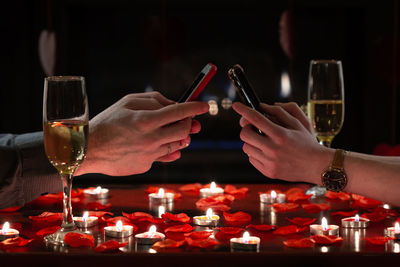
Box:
(321, 149), (347, 192)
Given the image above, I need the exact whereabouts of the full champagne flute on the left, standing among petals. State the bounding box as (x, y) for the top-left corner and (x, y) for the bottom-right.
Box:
(43, 76), (89, 245)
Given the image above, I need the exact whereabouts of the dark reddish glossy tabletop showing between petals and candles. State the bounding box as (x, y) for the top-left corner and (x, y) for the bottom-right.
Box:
(0, 184), (400, 266)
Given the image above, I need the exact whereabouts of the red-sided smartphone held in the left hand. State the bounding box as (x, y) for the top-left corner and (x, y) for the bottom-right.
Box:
(178, 63), (217, 103)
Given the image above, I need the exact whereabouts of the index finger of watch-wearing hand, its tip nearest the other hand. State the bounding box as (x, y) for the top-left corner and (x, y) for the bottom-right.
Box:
(232, 102), (284, 137)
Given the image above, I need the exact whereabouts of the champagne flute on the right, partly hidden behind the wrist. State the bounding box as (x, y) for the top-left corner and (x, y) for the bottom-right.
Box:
(307, 60), (344, 147)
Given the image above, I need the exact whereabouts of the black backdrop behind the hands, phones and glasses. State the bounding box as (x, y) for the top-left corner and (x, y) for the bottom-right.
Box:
(0, 0), (400, 183)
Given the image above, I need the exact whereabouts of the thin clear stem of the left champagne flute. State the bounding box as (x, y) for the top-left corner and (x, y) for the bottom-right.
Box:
(61, 173), (75, 231)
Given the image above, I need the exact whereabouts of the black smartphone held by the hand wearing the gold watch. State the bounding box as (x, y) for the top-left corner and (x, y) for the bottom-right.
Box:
(228, 64), (264, 114)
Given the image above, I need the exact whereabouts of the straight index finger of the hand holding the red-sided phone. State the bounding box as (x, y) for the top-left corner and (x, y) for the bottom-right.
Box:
(147, 102), (209, 129)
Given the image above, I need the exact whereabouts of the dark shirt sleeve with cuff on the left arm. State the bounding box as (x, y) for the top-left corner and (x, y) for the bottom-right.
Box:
(0, 132), (62, 209)
